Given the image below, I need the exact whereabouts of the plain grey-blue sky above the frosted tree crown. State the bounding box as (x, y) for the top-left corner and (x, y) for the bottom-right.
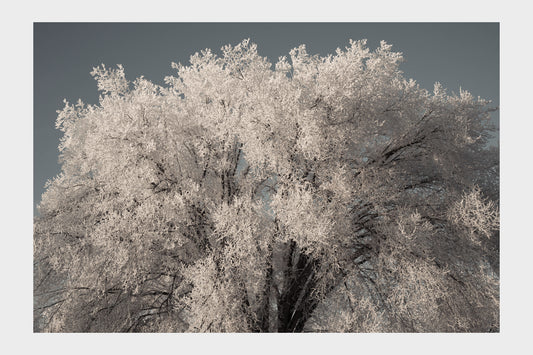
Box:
(33, 23), (500, 214)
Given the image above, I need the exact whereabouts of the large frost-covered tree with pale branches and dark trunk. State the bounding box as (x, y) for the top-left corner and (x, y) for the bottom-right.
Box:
(34, 40), (499, 332)
